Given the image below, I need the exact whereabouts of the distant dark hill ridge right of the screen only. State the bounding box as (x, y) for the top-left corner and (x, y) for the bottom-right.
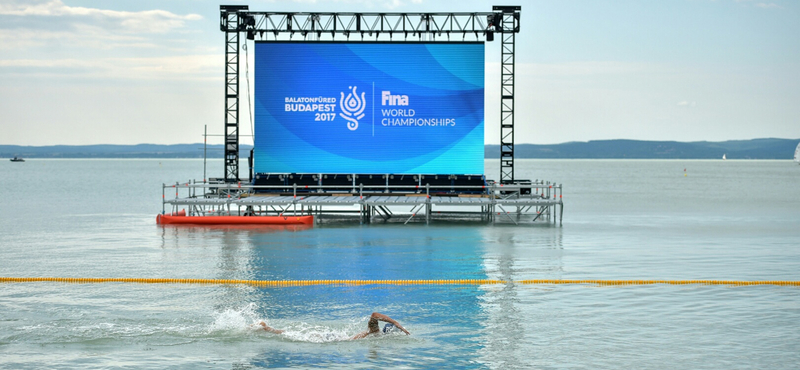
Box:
(485, 139), (800, 159)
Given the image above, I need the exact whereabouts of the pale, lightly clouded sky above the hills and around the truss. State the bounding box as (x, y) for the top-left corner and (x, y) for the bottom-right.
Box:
(0, 0), (800, 145)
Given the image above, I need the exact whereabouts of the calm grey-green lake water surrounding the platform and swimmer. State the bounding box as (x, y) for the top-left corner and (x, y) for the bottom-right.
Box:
(0, 159), (800, 369)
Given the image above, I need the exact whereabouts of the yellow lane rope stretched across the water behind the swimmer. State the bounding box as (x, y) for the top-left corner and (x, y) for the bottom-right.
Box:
(0, 277), (800, 287)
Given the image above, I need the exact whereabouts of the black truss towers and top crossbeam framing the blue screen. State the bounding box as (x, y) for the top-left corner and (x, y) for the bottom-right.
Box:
(219, 5), (522, 184)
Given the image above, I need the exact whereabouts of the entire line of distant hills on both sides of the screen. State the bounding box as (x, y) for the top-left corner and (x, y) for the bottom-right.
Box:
(0, 139), (800, 159)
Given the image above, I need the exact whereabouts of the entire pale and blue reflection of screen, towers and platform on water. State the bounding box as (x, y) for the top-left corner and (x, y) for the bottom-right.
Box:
(156, 225), (563, 367)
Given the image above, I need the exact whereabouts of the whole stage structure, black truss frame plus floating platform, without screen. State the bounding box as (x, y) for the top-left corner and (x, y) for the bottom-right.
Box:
(162, 5), (564, 224)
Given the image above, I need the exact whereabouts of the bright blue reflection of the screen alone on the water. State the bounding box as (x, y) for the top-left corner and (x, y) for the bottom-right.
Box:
(242, 225), (487, 366)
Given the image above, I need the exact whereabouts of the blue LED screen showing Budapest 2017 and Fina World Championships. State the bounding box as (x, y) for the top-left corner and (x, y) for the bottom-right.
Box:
(254, 42), (484, 174)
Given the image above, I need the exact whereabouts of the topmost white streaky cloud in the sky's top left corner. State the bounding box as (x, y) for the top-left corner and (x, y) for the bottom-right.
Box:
(0, 0), (208, 59)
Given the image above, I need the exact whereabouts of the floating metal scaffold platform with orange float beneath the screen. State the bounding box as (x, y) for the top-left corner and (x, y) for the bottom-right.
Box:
(157, 180), (564, 225)
